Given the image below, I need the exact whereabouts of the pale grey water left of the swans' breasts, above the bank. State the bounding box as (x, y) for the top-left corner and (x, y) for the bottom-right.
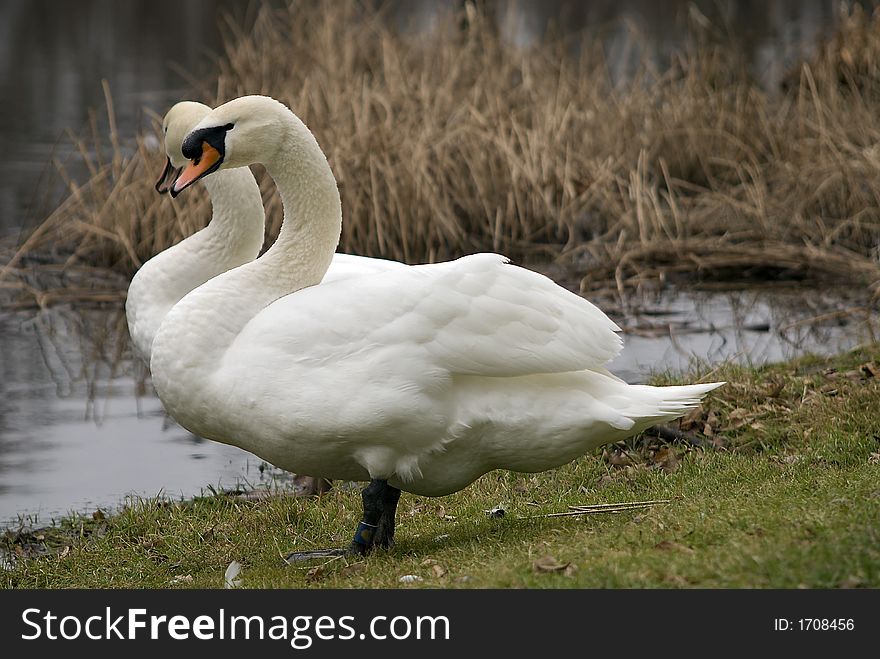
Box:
(0, 309), (272, 526)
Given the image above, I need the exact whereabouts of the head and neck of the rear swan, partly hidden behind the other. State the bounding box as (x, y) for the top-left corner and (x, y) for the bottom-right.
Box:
(125, 101), (265, 363)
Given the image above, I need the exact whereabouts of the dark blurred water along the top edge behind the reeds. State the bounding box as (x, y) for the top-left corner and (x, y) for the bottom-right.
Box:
(0, 0), (875, 236)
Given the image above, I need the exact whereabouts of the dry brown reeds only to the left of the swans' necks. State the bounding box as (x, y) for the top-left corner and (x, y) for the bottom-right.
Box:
(0, 83), (217, 308)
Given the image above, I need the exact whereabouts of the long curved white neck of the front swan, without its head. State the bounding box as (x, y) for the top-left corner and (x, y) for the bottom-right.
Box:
(151, 108), (342, 386)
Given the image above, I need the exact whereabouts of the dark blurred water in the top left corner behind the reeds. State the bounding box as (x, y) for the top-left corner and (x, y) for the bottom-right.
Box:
(0, 0), (234, 235)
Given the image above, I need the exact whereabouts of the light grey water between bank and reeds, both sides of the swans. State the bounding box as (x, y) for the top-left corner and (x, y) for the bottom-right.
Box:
(0, 291), (874, 526)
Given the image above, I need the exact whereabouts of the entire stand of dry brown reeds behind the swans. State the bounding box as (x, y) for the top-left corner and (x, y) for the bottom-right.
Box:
(5, 2), (880, 310)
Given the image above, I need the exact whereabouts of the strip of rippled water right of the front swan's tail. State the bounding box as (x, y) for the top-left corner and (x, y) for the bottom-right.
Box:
(610, 289), (877, 382)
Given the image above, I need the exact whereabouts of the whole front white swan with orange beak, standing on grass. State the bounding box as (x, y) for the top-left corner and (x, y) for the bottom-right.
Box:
(158, 96), (720, 558)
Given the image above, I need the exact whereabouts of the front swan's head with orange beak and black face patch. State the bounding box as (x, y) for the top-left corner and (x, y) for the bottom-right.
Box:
(170, 96), (294, 197)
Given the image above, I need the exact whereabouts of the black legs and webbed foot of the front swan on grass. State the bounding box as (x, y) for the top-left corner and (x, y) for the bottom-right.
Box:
(287, 479), (400, 563)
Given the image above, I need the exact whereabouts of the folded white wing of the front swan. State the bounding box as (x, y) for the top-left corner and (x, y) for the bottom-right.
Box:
(233, 254), (621, 377)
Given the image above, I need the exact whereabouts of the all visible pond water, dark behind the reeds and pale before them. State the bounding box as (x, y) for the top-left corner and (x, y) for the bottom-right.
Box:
(0, 0), (870, 526)
